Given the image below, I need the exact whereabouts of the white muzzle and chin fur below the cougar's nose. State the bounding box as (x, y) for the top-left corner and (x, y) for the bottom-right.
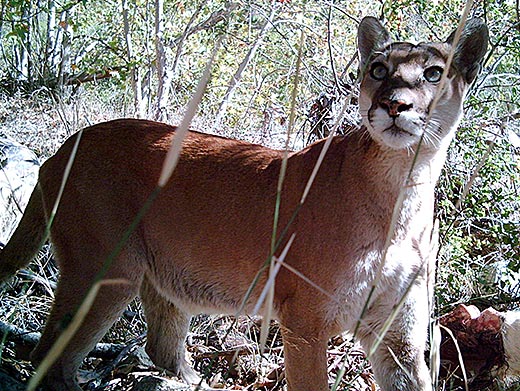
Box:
(365, 108), (422, 149)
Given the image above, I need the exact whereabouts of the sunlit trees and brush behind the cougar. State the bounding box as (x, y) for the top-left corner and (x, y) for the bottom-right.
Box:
(0, 0), (520, 390)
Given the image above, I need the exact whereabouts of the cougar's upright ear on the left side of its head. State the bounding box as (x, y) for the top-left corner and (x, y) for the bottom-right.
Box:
(358, 16), (392, 69)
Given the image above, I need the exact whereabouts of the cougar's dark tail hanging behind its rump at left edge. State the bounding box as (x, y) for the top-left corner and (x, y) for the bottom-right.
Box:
(0, 184), (47, 283)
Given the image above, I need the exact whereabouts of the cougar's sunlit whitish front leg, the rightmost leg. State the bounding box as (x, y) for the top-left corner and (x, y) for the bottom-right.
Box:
(361, 281), (432, 391)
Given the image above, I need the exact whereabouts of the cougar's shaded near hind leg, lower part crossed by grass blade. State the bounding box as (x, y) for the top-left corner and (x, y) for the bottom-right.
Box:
(31, 251), (142, 391)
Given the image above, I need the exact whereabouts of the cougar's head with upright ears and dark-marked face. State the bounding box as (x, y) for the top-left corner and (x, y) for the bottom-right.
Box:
(358, 17), (488, 149)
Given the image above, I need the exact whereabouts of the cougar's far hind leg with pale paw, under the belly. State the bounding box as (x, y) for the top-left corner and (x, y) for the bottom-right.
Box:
(140, 277), (200, 384)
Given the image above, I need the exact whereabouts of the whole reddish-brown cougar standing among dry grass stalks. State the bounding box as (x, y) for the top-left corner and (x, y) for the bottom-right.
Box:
(0, 17), (488, 391)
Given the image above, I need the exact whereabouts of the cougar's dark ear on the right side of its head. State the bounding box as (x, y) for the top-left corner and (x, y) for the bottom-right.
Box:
(446, 18), (489, 83)
